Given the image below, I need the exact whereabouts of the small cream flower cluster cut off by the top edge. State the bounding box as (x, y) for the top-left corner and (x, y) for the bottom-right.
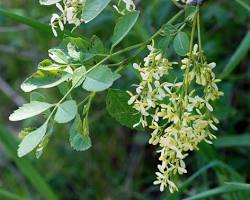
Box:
(50, 0), (85, 37)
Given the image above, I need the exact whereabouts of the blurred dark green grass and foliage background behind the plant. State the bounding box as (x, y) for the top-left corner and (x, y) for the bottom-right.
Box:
(0, 0), (250, 200)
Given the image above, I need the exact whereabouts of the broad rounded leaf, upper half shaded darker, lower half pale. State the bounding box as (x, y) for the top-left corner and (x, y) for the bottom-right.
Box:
(82, 65), (113, 92)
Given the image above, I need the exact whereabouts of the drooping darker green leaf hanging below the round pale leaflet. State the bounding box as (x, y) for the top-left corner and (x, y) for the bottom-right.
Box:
(69, 114), (92, 151)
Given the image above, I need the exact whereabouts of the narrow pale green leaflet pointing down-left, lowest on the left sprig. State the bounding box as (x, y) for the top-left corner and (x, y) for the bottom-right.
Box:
(17, 122), (48, 157)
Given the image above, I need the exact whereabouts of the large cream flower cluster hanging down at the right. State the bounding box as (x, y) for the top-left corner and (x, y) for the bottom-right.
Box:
(128, 42), (223, 192)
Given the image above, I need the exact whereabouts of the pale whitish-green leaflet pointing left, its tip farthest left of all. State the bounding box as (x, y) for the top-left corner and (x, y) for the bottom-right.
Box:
(9, 101), (53, 121)
